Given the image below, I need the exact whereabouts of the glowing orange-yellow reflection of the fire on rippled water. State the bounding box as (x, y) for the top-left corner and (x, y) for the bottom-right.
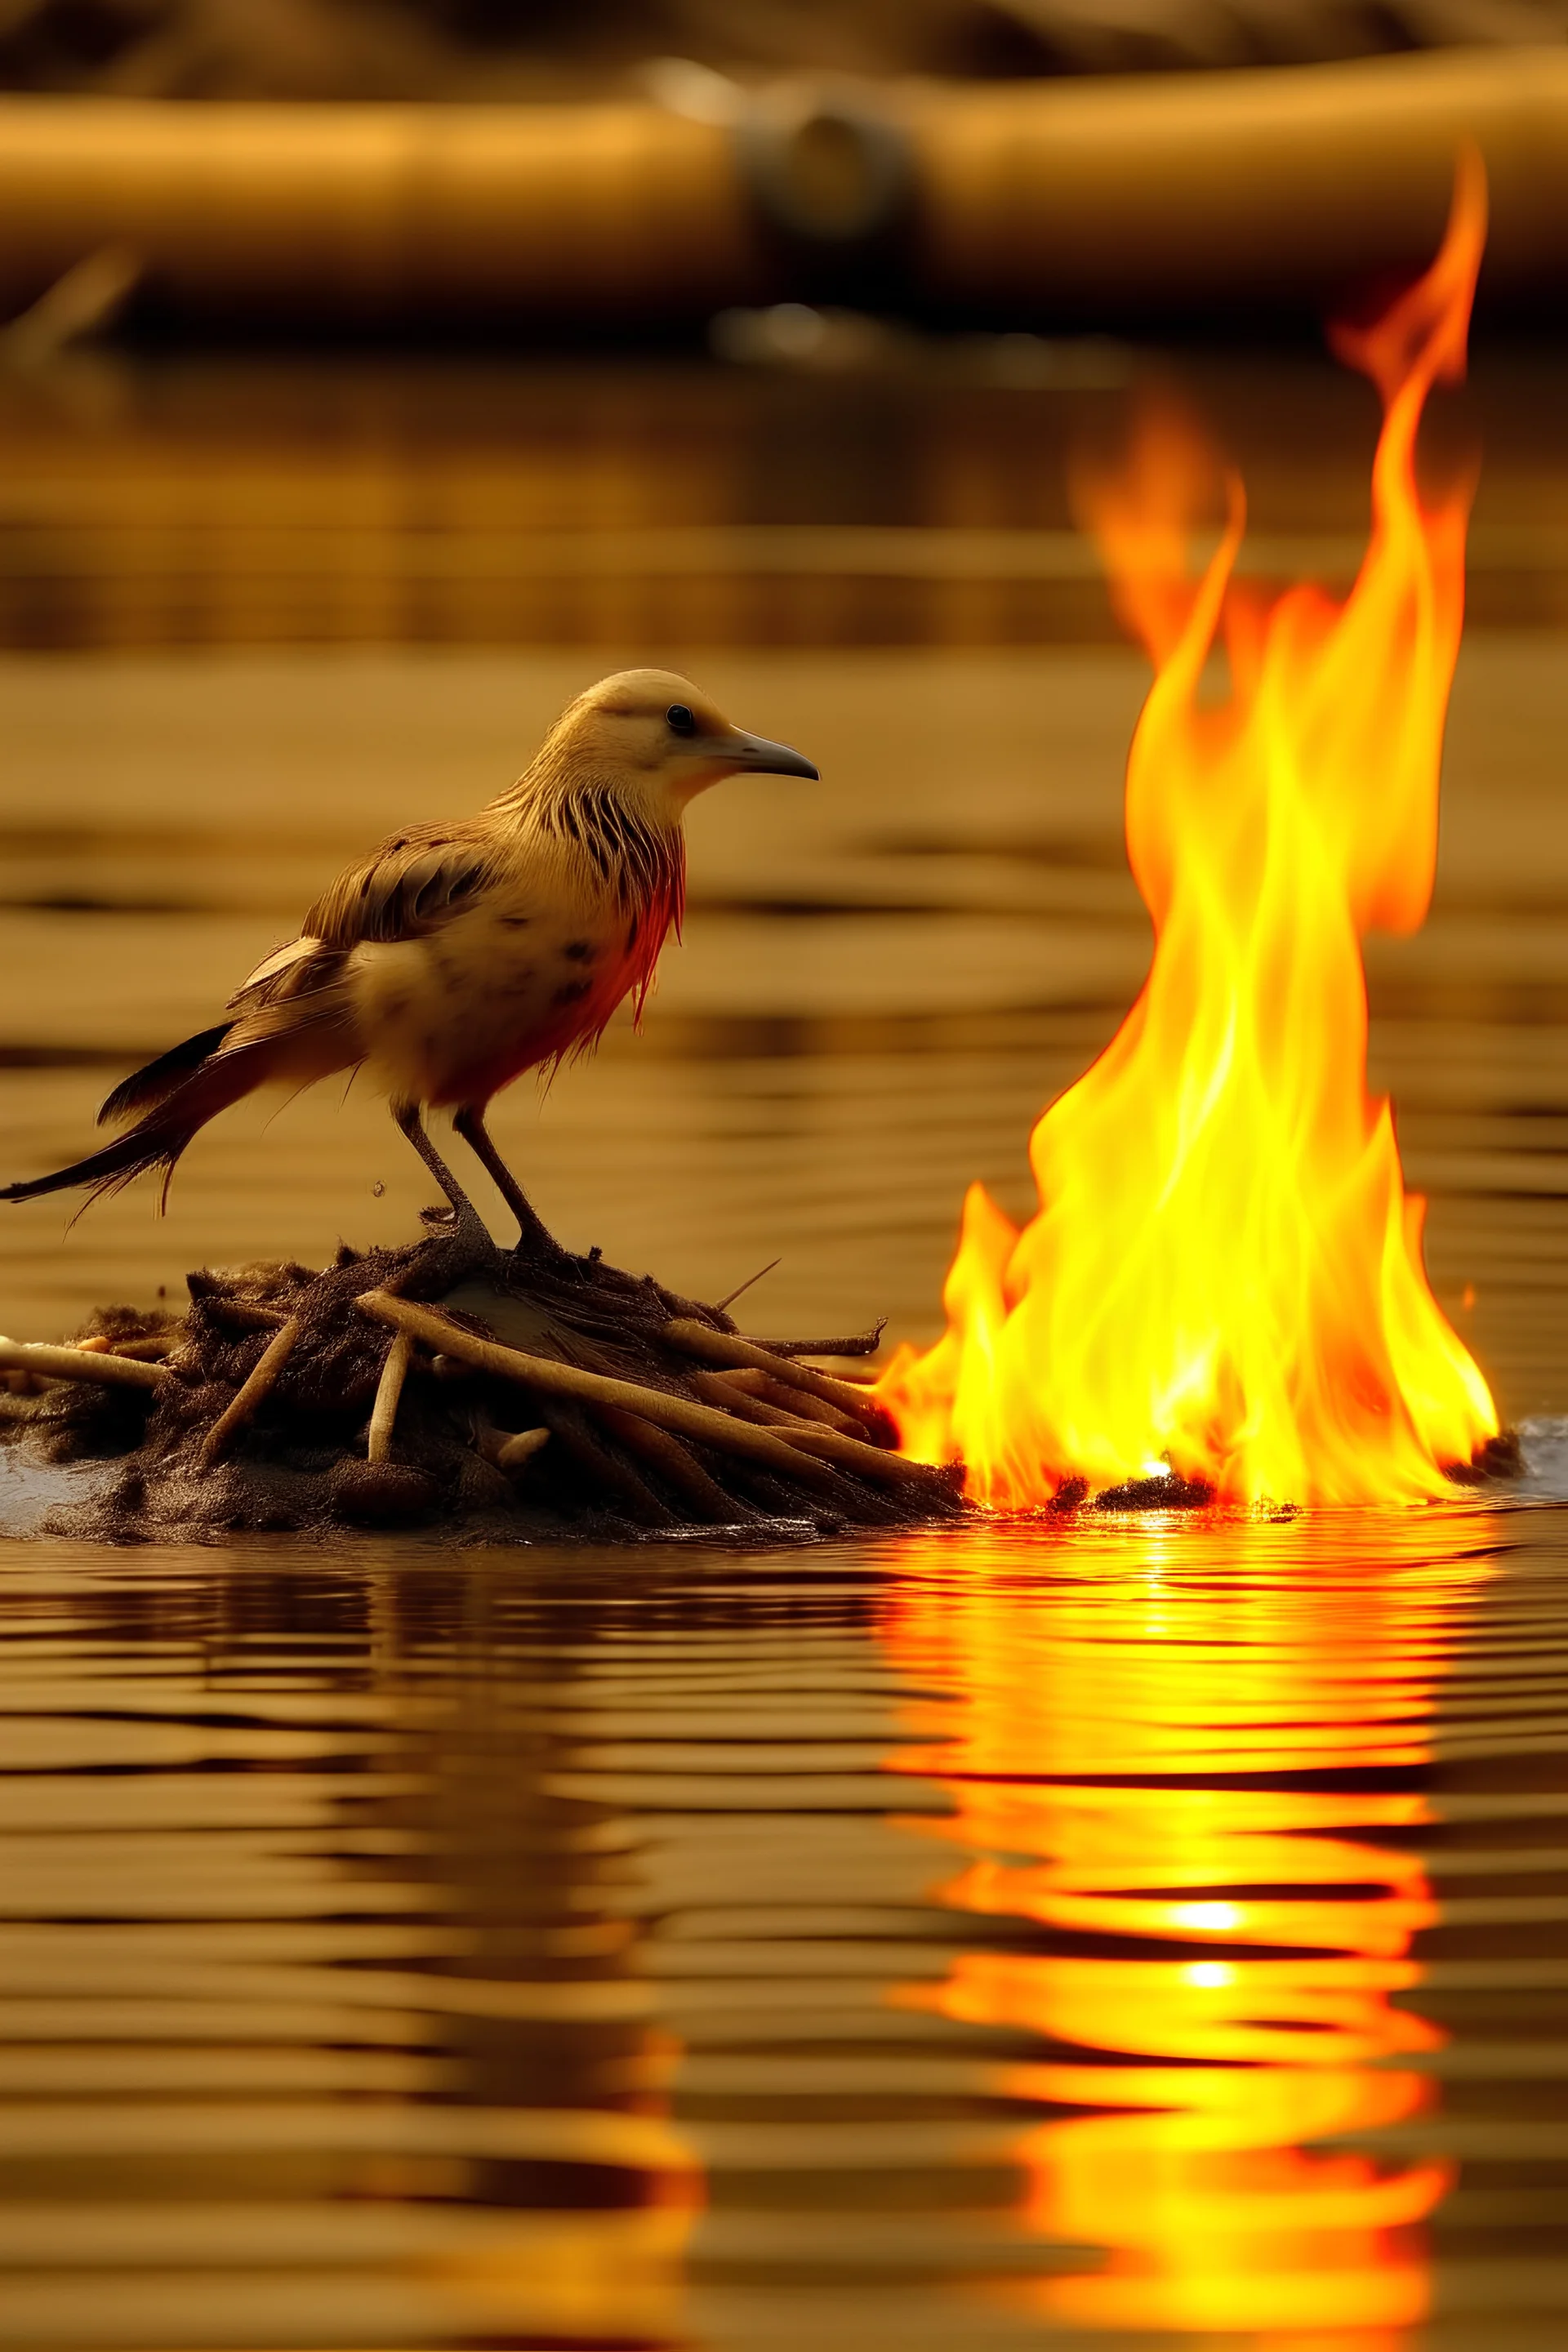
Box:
(886, 1515), (1488, 2352)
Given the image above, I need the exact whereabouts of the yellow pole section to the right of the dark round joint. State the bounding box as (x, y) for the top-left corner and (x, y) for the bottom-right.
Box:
(915, 49), (1568, 324)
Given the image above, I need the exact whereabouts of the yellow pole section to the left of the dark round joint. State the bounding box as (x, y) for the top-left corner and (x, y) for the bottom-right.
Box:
(0, 96), (764, 327)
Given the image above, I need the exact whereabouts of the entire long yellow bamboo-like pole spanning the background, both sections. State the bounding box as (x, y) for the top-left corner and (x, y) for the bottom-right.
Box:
(0, 47), (1568, 329)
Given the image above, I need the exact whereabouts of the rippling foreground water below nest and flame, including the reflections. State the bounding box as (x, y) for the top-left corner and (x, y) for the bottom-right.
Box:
(0, 1510), (1568, 2347)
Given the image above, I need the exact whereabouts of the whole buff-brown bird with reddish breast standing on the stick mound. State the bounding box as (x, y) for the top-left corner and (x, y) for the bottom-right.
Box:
(0, 670), (818, 1256)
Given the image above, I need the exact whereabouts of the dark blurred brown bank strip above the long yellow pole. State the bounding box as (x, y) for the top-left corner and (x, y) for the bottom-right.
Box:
(0, 0), (1568, 99)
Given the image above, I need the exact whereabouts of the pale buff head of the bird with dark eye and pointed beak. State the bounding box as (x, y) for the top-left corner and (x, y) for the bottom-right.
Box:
(533, 670), (818, 823)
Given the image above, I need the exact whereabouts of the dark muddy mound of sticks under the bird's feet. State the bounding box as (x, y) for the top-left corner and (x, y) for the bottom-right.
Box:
(0, 1235), (964, 1543)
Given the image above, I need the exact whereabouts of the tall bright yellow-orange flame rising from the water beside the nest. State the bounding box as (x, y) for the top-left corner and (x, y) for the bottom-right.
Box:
(880, 155), (1498, 1508)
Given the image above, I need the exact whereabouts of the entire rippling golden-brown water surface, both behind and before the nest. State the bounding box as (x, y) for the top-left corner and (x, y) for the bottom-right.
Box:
(0, 345), (1568, 2352)
